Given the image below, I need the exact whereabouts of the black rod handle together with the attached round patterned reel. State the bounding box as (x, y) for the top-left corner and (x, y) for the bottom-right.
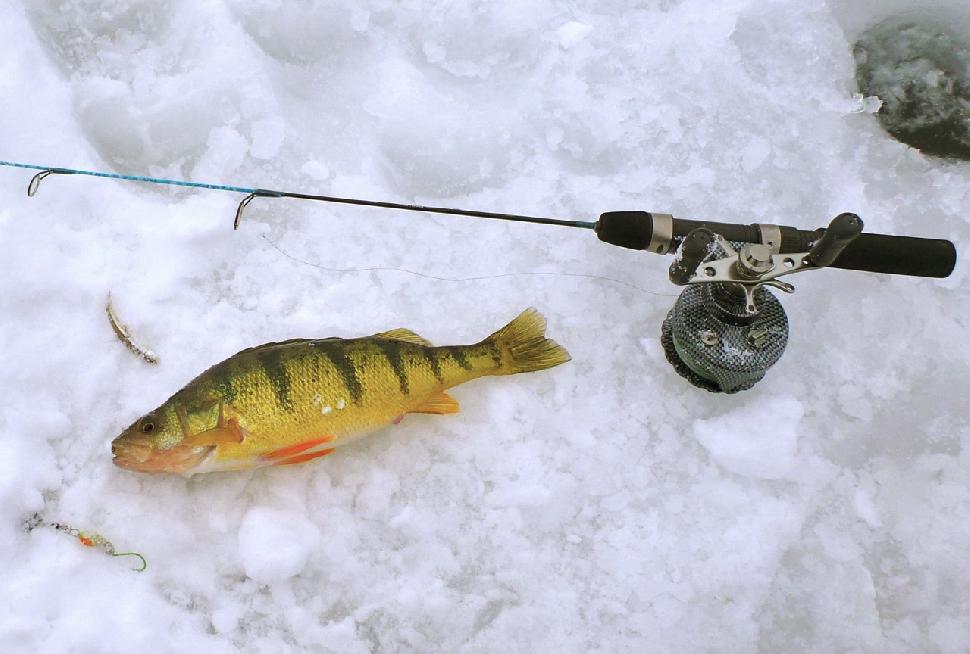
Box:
(595, 211), (956, 393)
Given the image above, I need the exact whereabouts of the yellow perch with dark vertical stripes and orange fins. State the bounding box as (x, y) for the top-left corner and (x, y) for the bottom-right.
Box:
(111, 308), (570, 476)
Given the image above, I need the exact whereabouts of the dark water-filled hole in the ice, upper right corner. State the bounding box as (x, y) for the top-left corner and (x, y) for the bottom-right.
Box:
(854, 20), (970, 161)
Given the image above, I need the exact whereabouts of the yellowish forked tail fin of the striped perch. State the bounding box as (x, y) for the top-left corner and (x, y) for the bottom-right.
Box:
(484, 308), (572, 375)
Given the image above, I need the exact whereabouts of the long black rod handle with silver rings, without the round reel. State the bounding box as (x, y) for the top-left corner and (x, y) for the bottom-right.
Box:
(595, 211), (957, 278)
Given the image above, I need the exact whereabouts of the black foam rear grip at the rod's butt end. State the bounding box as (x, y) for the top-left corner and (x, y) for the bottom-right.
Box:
(830, 233), (957, 277)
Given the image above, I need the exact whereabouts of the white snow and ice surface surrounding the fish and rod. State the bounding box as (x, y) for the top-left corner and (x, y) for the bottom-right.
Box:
(0, 0), (970, 653)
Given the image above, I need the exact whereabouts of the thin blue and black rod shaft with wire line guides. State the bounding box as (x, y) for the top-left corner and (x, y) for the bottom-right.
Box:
(0, 160), (596, 229)
